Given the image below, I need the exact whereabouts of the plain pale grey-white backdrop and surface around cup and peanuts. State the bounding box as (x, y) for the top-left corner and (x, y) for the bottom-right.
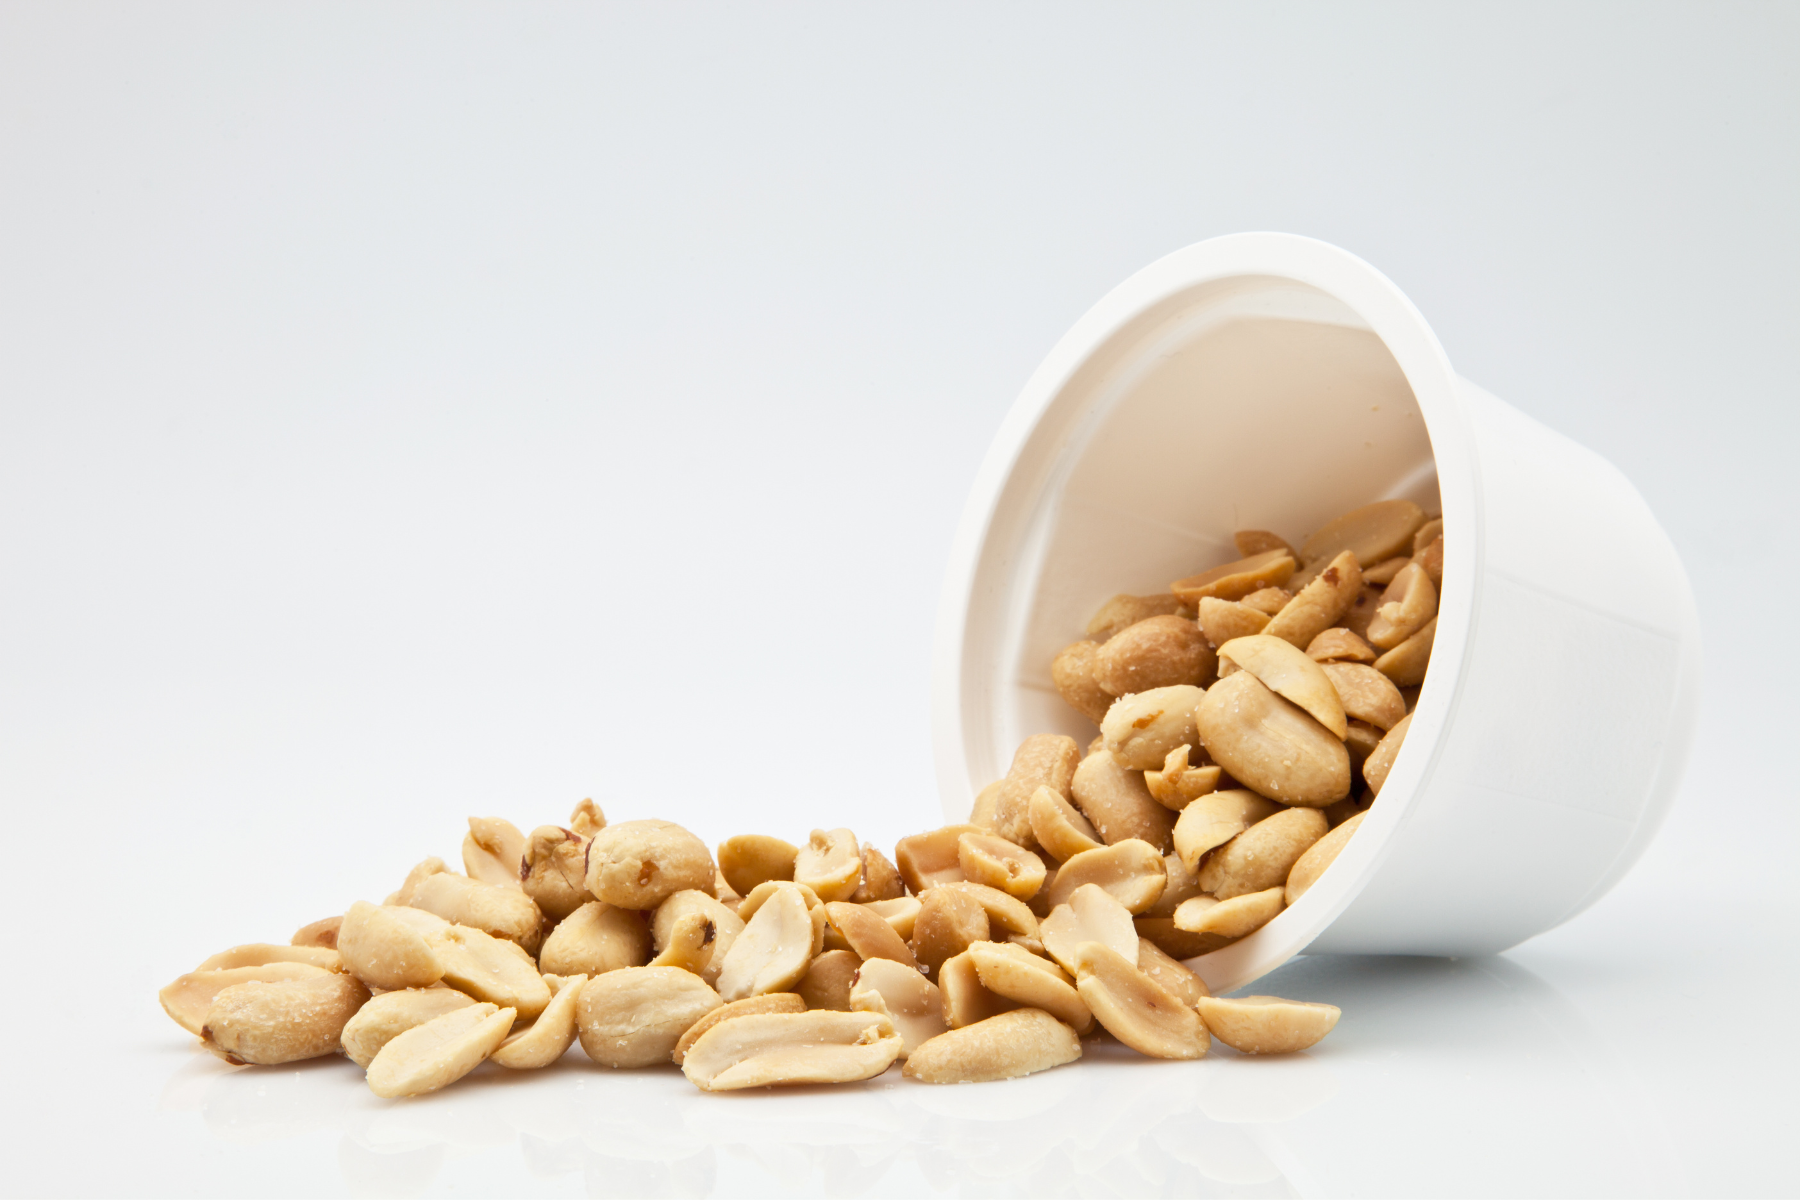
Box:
(0, 4), (1800, 1196)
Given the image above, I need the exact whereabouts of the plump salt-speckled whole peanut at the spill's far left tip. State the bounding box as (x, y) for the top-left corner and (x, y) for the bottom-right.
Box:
(200, 972), (369, 1067)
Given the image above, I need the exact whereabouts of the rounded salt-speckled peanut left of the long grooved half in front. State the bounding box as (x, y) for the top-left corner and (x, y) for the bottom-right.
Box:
(576, 964), (720, 1067)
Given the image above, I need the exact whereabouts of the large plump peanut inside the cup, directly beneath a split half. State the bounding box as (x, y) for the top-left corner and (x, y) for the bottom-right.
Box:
(1195, 676), (1350, 808)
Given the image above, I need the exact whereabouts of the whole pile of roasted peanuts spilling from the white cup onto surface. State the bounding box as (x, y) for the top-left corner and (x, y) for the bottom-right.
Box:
(160, 502), (1442, 1097)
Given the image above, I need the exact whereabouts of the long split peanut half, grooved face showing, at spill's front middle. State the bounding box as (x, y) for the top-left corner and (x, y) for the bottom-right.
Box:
(680, 1009), (900, 1092)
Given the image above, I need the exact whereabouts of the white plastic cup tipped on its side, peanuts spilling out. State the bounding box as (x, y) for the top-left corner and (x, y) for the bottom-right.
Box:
(932, 234), (1699, 993)
